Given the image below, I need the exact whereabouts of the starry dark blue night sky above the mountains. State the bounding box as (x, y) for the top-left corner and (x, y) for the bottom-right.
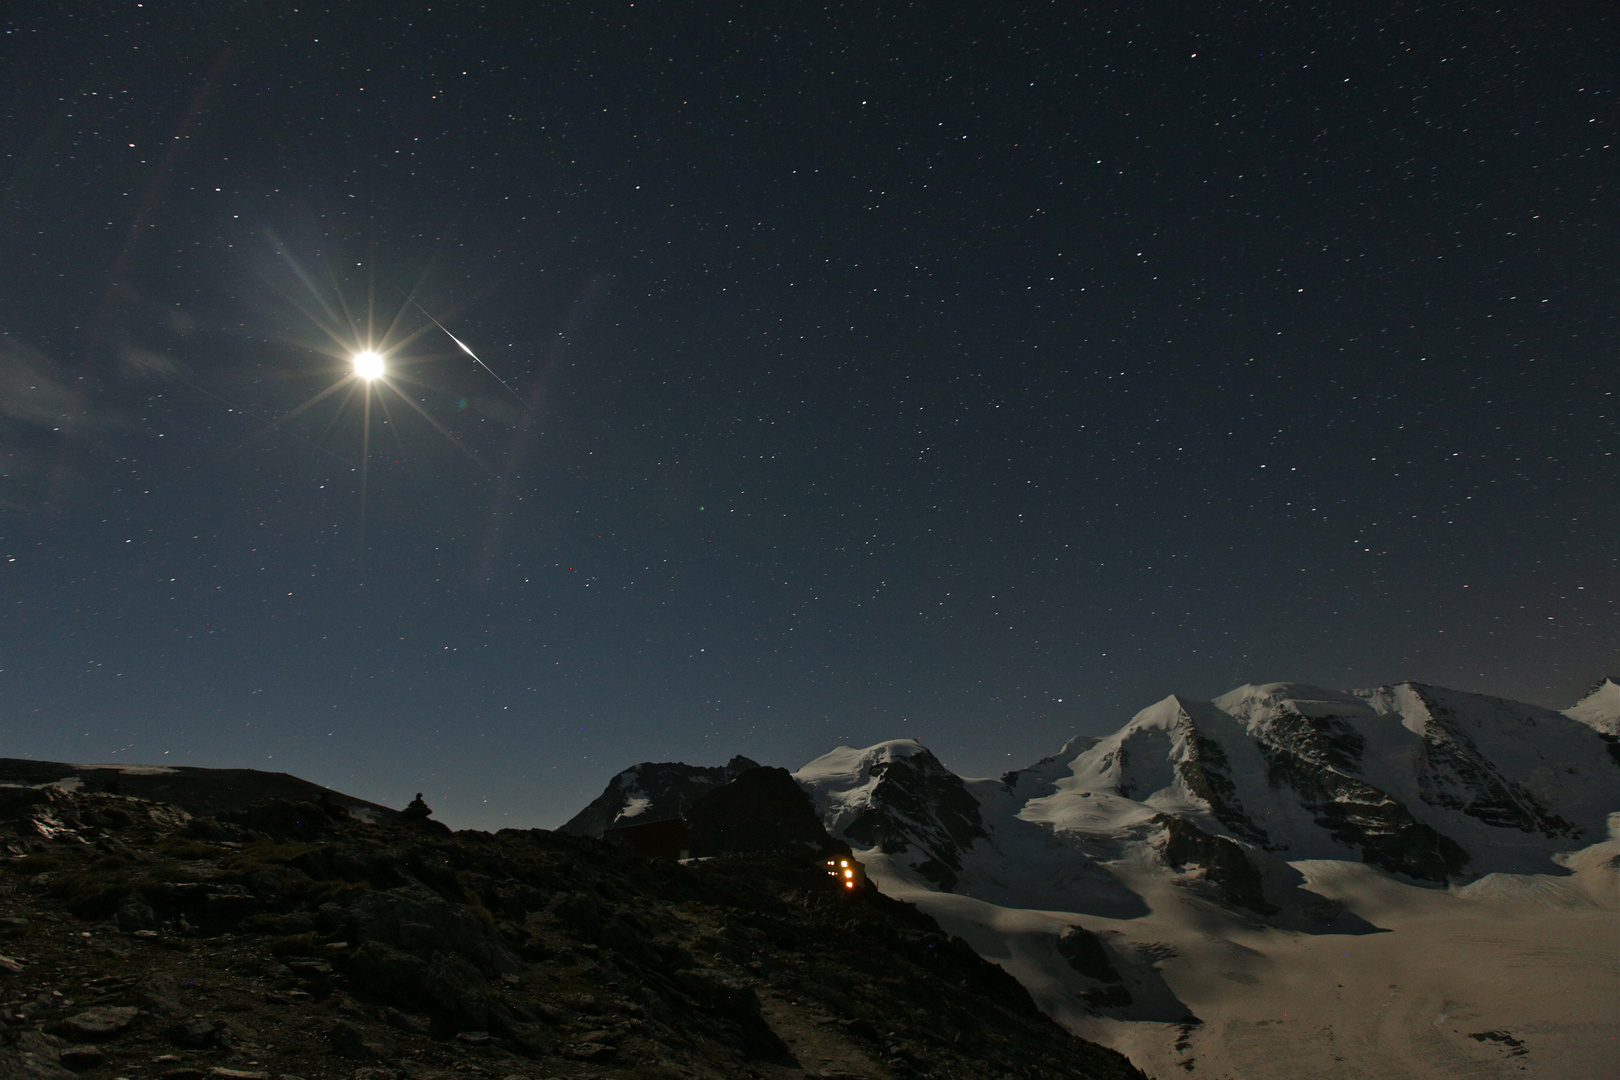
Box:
(0, 0), (1620, 827)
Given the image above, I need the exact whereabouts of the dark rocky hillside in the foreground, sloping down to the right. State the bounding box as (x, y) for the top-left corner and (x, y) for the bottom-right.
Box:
(0, 787), (1142, 1080)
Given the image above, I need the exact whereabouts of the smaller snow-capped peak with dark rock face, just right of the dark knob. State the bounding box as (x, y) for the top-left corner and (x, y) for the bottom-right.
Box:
(794, 740), (988, 891)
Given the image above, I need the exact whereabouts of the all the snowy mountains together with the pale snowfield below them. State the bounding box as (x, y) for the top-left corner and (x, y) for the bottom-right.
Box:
(795, 683), (1620, 1080)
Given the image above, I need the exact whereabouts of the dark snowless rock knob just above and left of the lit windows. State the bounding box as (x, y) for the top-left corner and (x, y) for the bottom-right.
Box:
(685, 767), (833, 857)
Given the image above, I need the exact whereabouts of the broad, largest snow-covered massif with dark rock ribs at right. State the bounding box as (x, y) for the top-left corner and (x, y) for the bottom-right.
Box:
(1006, 683), (1620, 881)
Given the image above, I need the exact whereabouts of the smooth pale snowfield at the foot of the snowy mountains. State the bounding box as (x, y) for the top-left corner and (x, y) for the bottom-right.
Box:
(868, 839), (1620, 1080)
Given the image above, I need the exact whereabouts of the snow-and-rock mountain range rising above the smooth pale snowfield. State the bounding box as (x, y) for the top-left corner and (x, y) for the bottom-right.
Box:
(570, 680), (1620, 916)
